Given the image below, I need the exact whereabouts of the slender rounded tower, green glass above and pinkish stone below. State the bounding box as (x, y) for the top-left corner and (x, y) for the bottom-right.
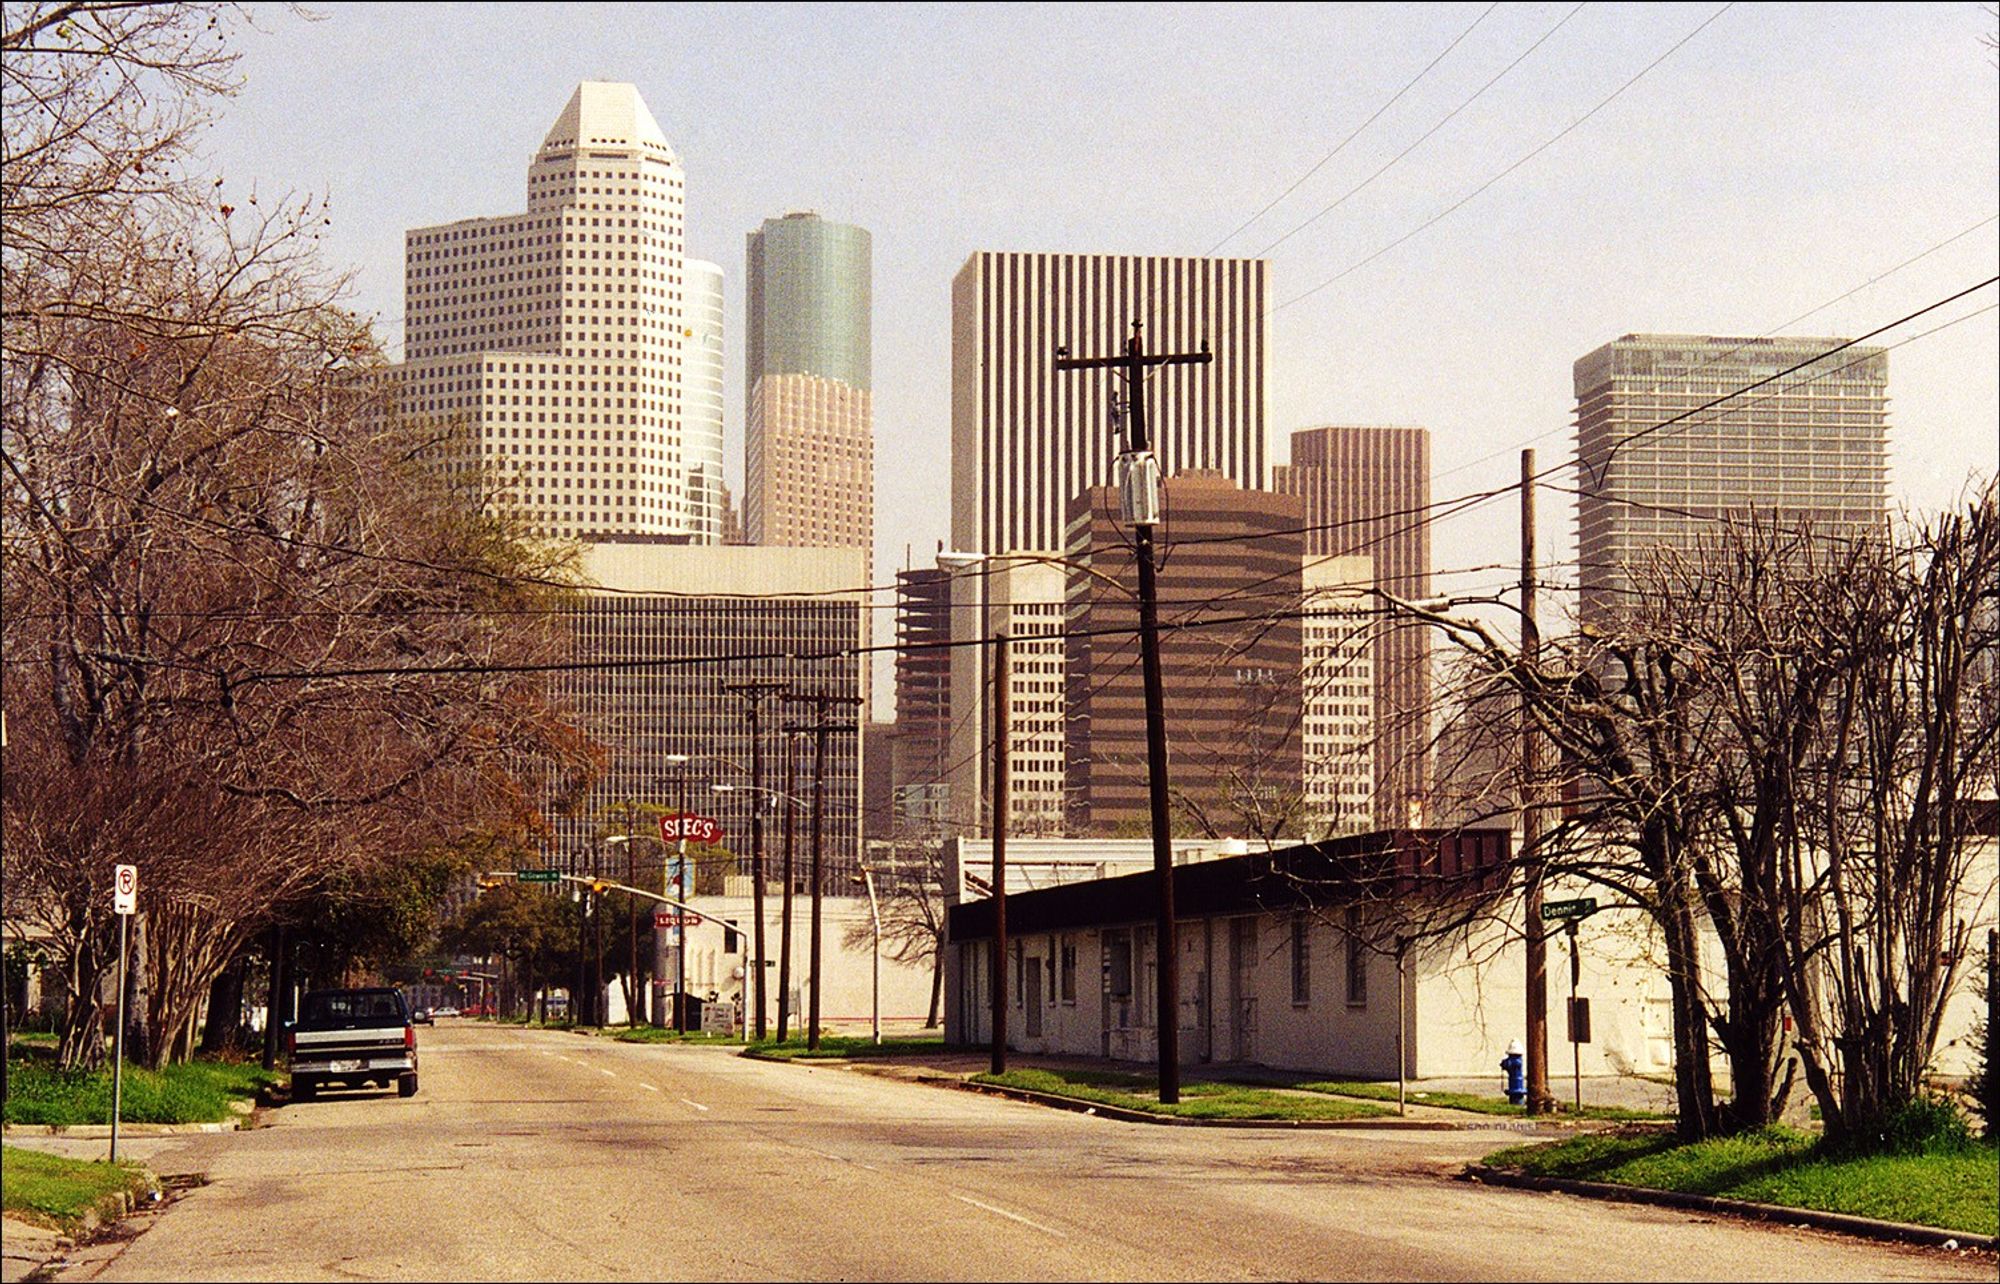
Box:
(744, 212), (874, 548)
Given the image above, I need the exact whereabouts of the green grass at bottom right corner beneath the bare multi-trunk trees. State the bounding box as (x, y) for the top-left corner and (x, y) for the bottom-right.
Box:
(1486, 1128), (2000, 1234)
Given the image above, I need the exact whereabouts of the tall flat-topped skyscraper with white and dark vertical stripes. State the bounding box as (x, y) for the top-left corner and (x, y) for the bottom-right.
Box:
(950, 250), (1268, 824)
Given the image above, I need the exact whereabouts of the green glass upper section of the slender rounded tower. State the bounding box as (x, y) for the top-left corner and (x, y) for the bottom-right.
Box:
(744, 212), (874, 390)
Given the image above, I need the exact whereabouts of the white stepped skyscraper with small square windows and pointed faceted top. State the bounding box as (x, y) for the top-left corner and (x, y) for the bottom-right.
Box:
(398, 80), (700, 540)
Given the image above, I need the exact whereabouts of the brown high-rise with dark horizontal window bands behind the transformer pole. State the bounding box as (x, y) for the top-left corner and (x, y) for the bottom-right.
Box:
(1064, 472), (1304, 838)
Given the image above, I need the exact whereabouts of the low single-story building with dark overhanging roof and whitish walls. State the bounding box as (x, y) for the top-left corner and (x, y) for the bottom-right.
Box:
(944, 804), (1994, 1082)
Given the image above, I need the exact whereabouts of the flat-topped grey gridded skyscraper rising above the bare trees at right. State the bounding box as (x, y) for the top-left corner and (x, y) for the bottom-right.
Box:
(1576, 334), (1888, 624)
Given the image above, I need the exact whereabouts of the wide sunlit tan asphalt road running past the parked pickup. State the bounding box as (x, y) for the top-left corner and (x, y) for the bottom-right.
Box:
(60, 1022), (1992, 1284)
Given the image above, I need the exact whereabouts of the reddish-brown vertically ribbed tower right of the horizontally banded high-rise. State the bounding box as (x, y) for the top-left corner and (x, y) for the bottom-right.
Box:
(1270, 424), (1430, 828)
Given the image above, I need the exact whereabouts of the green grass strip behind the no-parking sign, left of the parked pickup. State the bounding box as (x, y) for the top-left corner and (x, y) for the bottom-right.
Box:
(6, 1058), (280, 1128)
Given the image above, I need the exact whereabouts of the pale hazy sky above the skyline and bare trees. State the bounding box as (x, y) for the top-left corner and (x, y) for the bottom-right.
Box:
(206, 0), (2000, 704)
